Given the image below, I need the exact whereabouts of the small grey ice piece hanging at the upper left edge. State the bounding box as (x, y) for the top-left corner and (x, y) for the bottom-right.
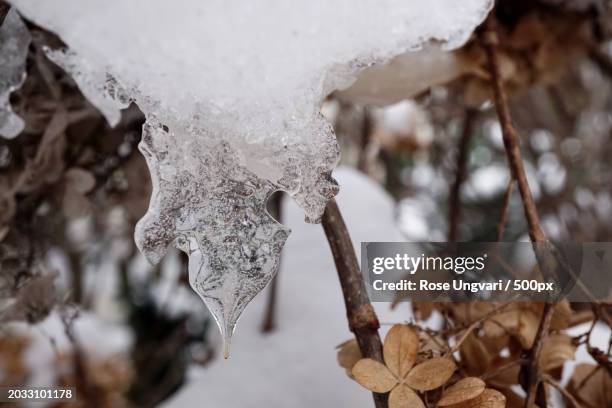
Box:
(0, 10), (30, 139)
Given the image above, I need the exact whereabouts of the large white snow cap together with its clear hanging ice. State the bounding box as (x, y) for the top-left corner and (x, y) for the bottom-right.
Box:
(11, 0), (491, 354)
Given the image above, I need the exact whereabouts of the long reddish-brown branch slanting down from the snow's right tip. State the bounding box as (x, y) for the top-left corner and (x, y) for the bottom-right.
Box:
(480, 14), (554, 407)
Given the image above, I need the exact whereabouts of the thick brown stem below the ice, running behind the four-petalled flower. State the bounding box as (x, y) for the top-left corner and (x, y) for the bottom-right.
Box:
(321, 199), (387, 408)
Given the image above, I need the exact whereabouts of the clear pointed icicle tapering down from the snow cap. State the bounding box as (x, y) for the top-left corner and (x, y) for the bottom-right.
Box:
(136, 120), (290, 353)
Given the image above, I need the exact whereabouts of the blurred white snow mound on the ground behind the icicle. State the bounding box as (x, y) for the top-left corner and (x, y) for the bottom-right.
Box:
(166, 168), (409, 408)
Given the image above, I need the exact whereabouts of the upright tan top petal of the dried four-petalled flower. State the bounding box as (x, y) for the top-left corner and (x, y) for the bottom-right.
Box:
(383, 324), (419, 378)
